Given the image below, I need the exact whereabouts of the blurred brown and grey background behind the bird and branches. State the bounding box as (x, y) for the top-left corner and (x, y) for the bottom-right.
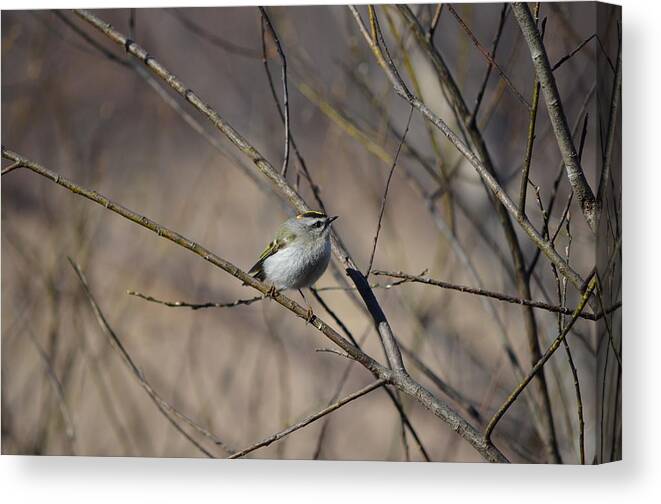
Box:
(1, 2), (621, 463)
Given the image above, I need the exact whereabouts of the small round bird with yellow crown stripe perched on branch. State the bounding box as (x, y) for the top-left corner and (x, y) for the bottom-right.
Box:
(248, 211), (337, 322)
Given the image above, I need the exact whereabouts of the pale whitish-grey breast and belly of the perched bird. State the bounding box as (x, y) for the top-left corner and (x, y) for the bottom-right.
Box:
(264, 237), (331, 289)
